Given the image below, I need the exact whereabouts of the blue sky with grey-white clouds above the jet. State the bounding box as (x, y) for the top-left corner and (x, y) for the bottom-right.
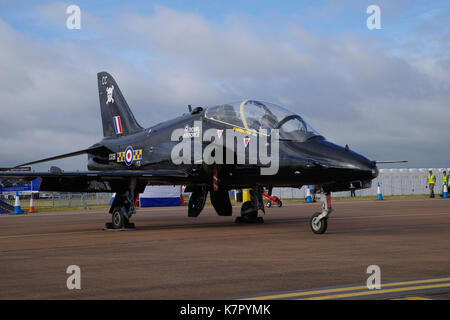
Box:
(0, 0), (450, 170)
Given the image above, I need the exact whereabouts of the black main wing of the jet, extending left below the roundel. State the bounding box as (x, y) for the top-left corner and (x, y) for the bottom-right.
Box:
(0, 170), (189, 192)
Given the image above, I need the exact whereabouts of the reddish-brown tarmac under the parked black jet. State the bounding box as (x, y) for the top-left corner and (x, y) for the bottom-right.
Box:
(0, 199), (450, 299)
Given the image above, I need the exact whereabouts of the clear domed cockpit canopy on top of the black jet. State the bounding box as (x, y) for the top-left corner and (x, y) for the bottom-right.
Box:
(205, 100), (320, 141)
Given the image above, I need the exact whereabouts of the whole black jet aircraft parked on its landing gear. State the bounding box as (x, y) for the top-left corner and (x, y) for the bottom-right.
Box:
(0, 72), (394, 234)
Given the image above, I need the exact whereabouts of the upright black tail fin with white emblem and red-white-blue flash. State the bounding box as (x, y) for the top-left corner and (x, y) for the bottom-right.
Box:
(97, 72), (143, 137)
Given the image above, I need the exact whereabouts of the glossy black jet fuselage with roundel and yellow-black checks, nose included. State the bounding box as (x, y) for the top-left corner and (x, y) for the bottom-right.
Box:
(88, 110), (378, 191)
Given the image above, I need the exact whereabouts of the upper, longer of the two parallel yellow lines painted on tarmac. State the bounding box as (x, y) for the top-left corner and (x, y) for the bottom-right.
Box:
(243, 278), (450, 300)
